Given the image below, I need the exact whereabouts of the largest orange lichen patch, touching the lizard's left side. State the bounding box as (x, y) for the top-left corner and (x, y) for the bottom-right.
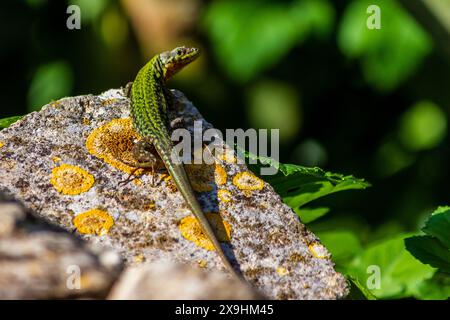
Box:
(86, 118), (144, 175)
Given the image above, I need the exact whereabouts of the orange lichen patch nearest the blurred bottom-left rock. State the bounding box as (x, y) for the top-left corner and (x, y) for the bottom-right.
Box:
(72, 209), (114, 236)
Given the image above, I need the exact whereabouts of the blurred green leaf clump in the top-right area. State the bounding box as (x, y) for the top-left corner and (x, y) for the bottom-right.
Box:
(338, 0), (432, 91)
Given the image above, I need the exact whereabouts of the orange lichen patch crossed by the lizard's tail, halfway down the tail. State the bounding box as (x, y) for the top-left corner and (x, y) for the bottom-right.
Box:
(178, 213), (231, 251)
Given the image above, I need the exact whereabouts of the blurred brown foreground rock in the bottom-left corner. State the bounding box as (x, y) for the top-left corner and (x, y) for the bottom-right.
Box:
(0, 195), (121, 299)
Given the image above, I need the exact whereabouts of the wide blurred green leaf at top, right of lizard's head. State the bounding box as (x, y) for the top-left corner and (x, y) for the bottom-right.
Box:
(202, 0), (334, 81)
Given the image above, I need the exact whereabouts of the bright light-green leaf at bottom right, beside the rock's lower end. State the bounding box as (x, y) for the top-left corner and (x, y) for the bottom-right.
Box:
(346, 235), (435, 298)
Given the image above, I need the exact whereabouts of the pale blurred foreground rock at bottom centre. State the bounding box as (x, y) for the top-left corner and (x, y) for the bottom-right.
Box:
(108, 261), (263, 300)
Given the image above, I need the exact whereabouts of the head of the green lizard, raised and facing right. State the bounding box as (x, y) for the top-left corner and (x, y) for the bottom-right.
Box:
(159, 47), (200, 80)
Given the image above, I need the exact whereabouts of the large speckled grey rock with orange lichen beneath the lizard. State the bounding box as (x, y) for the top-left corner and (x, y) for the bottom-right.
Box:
(0, 86), (348, 299)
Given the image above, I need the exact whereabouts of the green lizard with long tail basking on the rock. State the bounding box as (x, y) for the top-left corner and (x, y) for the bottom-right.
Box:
(127, 47), (239, 277)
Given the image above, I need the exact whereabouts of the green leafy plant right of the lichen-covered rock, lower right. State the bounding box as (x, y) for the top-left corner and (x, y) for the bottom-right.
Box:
(248, 152), (450, 299)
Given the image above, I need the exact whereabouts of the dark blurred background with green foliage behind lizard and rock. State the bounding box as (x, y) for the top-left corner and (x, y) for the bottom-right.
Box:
(0, 0), (450, 241)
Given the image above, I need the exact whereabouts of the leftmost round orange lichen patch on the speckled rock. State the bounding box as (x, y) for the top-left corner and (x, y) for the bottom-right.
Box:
(50, 164), (95, 195)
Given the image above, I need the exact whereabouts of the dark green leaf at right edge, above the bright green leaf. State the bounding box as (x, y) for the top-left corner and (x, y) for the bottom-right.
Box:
(405, 236), (450, 273)
